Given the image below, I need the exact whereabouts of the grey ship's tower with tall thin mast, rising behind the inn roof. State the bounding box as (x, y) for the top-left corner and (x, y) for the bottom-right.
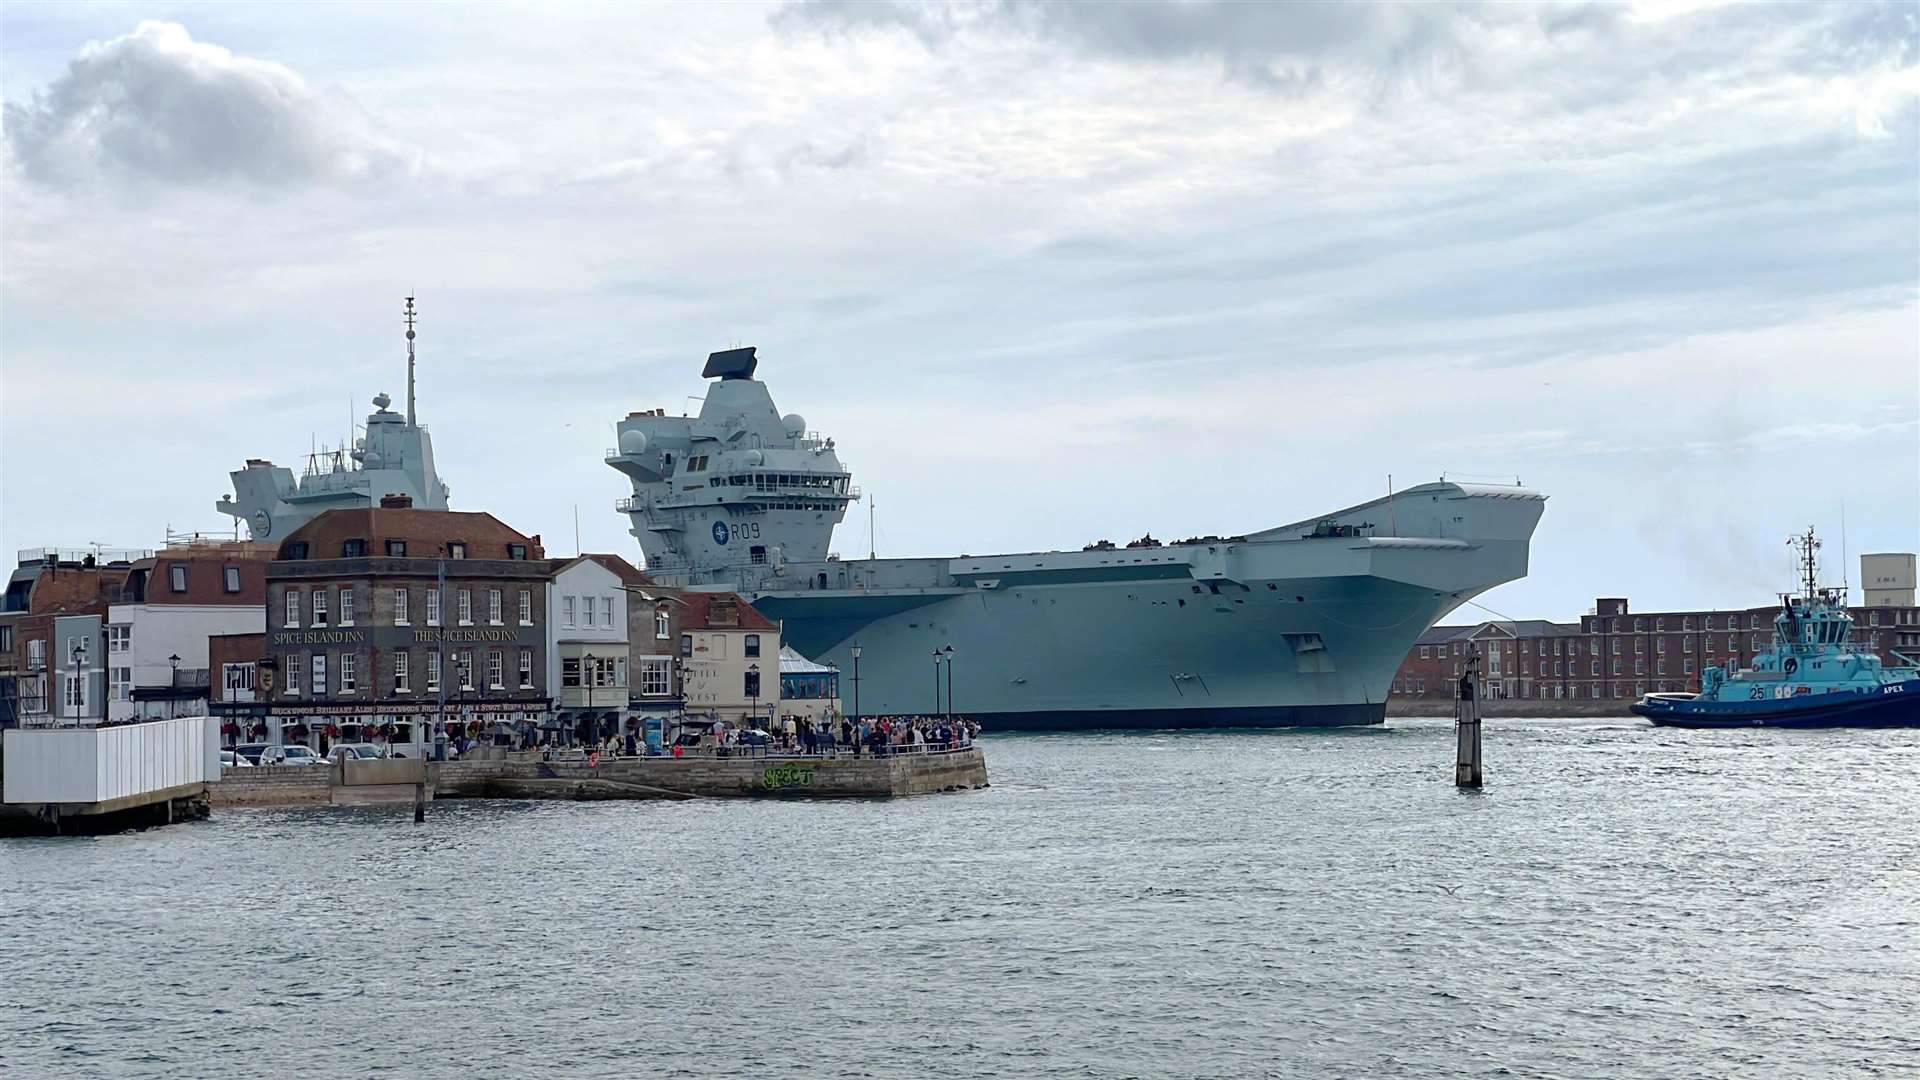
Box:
(213, 296), (449, 542)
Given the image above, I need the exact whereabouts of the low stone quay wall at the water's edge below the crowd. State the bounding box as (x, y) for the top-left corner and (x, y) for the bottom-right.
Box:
(209, 746), (987, 809)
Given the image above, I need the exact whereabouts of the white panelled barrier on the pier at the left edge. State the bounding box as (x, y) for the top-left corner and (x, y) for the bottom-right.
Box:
(0, 717), (221, 803)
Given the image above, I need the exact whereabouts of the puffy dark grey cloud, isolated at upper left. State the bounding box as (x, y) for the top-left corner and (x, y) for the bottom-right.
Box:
(6, 21), (411, 188)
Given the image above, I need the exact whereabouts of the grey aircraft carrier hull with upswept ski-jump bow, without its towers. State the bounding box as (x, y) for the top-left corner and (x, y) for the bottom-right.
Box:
(739, 484), (1544, 730)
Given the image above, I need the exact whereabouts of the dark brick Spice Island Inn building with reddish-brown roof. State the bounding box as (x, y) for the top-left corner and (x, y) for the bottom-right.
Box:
(259, 496), (551, 757)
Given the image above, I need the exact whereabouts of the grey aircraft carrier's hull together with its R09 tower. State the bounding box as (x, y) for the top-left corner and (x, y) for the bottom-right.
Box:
(607, 348), (1546, 730)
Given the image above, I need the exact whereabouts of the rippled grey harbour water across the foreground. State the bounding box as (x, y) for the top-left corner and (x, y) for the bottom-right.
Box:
(0, 719), (1920, 1078)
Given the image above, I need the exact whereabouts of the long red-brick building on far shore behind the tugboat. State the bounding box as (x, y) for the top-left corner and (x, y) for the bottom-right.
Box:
(1392, 594), (1920, 705)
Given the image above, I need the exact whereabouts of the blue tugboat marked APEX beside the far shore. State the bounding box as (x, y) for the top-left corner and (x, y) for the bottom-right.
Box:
(1632, 528), (1920, 728)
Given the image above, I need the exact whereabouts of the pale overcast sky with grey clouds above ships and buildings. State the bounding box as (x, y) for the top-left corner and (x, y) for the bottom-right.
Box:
(0, 0), (1920, 619)
